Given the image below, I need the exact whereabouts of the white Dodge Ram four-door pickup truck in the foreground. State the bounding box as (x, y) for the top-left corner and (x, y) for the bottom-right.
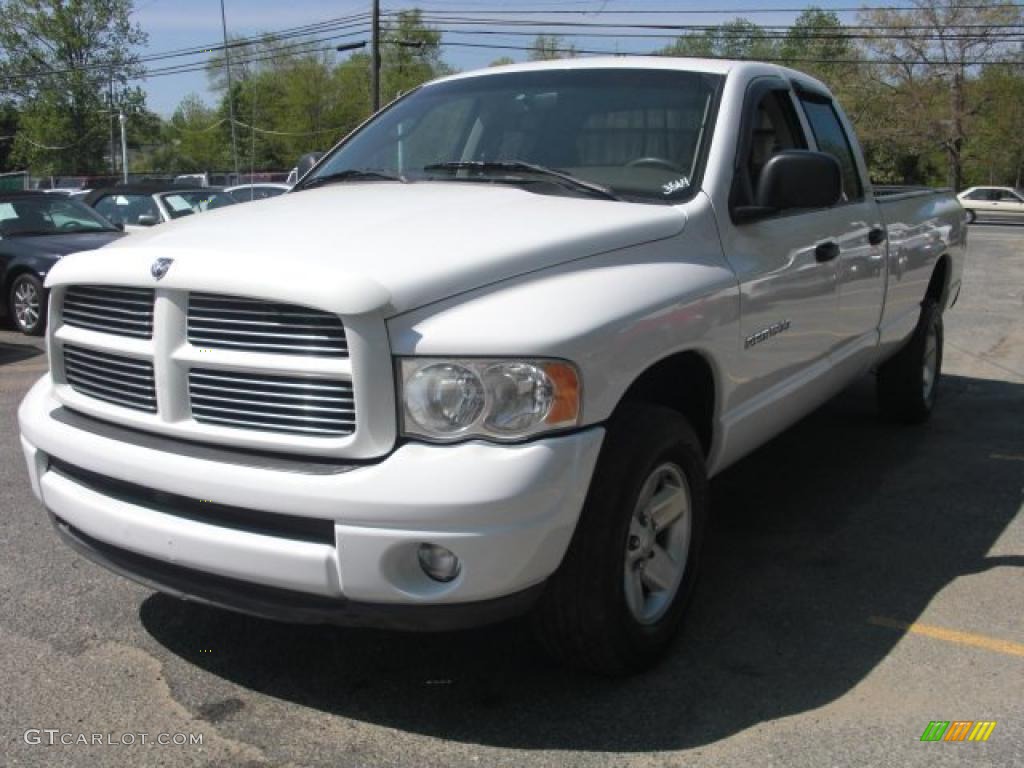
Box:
(19, 58), (967, 674)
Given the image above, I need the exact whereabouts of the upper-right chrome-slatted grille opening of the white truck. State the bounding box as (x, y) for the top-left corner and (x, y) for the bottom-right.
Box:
(188, 293), (348, 357)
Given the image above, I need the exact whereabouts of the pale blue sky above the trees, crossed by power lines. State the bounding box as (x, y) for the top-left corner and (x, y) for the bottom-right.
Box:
(134, 0), (860, 117)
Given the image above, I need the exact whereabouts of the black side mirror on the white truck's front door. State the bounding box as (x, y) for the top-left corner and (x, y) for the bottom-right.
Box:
(755, 150), (843, 211)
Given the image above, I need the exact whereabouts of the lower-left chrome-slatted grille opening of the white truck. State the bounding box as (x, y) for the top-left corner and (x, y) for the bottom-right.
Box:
(63, 344), (157, 414)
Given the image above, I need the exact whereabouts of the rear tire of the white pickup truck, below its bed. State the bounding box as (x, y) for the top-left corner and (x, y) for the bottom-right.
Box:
(878, 299), (943, 424)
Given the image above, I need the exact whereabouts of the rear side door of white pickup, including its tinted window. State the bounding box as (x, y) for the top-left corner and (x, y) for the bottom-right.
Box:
(798, 90), (886, 374)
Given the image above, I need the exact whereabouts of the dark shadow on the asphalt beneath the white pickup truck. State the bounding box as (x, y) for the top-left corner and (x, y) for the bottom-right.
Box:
(140, 377), (1024, 752)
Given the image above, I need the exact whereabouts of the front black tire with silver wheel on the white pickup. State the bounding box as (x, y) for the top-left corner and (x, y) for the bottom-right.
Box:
(534, 403), (708, 675)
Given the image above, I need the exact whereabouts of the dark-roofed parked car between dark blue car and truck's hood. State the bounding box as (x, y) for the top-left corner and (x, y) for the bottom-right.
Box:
(85, 184), (238, 231)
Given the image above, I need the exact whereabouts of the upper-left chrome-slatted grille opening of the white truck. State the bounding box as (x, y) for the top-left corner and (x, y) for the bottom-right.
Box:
(61, 286), (153, 339)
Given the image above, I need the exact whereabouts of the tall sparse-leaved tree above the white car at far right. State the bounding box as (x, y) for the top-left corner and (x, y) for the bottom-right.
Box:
(860, 0), (1024, 189)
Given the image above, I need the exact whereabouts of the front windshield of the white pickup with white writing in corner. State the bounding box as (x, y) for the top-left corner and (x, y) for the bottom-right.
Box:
(300, 69), (721, 203)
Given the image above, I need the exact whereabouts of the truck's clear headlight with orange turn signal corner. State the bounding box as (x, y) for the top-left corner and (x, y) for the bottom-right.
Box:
(399, 358), (580, 440)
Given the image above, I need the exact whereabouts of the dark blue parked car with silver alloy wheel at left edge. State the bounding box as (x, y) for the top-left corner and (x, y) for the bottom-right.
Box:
(0, 191), (124, 336)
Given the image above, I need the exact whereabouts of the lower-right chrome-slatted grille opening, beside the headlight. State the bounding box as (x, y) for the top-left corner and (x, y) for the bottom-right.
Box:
(188, 368), (355, 437)
